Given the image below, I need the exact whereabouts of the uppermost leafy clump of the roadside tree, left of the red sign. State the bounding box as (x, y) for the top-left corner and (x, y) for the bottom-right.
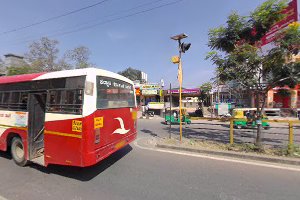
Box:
(208, 0), (287, 53)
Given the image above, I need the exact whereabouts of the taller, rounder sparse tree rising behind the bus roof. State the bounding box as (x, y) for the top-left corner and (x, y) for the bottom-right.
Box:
(25, 37), (59, 72)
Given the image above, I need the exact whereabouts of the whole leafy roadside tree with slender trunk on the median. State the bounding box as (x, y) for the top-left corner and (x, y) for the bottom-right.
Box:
(207, 0), (300, 147)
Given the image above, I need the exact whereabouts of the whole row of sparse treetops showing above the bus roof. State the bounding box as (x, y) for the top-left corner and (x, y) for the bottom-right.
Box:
(0, 37), (93, 75)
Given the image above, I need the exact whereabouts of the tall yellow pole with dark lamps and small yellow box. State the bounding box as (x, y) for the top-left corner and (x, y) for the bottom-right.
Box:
(170, 33), (191, 142)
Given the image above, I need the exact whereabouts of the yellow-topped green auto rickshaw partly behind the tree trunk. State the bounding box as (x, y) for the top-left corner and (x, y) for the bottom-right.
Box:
(233, 108), (270, 129)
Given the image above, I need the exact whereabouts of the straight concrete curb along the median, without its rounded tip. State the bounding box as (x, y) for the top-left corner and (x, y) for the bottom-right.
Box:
(155, 144), (300, 166)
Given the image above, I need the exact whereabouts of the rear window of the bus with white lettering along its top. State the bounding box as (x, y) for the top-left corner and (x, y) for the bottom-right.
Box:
(97, 76), (135, 109)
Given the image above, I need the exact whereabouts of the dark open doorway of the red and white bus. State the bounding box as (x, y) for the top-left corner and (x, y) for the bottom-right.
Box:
(28, 93), (47, 160)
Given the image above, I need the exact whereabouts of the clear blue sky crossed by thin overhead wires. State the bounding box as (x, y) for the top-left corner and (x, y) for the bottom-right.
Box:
(0, 0), (263, 88)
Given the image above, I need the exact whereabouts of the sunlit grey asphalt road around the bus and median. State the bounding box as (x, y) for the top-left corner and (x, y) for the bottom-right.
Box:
(0, 120), (300, 200)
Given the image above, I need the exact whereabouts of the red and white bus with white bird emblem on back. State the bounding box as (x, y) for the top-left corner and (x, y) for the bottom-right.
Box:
(0, 68), (137, 167)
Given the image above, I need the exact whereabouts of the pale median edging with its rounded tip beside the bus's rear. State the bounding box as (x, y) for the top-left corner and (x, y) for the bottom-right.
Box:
(136, 137), (300, 166)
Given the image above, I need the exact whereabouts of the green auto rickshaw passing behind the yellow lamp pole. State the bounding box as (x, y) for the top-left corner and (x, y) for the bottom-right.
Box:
(165, 107), (191, 124)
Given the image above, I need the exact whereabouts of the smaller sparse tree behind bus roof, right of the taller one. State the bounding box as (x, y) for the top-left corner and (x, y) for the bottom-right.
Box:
(65, 46), (93, 69)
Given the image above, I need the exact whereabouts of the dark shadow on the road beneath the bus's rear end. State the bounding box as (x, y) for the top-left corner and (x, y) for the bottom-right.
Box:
(29, 145), (132, 182)
